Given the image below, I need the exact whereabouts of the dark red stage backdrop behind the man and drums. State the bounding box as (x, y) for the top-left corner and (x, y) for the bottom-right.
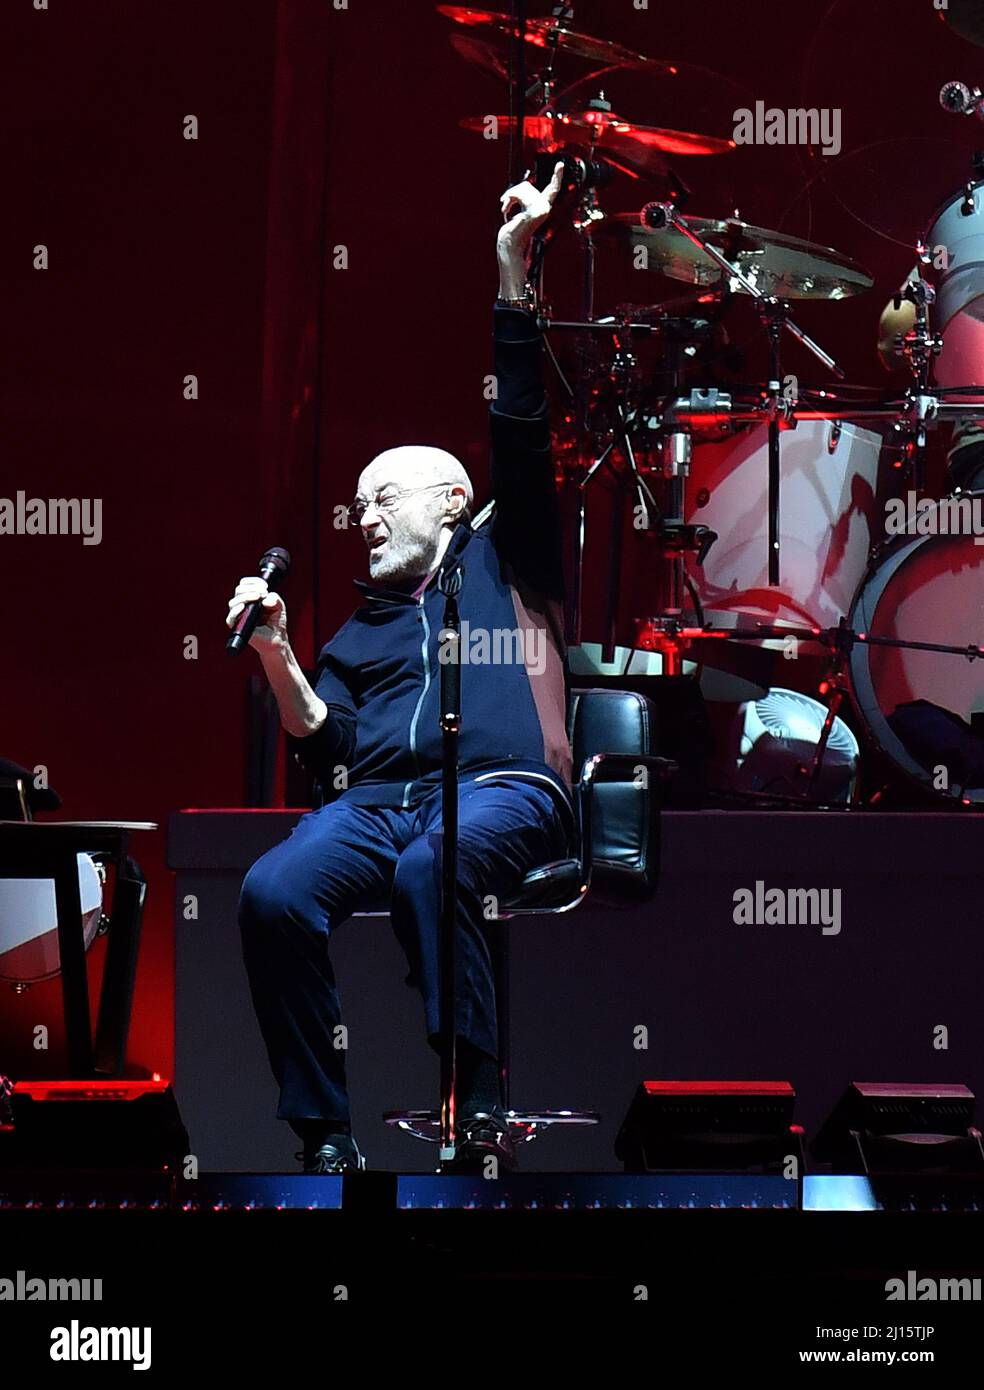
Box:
(0, 0), (984, 1095)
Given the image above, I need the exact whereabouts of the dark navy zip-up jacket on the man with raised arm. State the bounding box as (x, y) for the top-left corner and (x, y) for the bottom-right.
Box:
(288, 306), (571, 812)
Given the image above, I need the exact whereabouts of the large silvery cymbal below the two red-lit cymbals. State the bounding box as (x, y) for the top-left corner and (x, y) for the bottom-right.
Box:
(591, 213), (874, 299)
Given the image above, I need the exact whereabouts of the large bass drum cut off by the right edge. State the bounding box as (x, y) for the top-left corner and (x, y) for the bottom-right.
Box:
(848, 492), (984, 803)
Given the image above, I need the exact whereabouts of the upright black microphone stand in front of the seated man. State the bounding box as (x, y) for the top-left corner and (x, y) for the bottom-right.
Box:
(438, 560), (464, 1163)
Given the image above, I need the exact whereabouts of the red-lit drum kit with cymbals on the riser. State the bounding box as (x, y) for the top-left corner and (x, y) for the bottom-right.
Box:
(438, 3), (984, 806)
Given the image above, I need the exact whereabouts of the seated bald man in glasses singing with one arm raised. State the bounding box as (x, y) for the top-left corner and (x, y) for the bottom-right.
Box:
(227, 165), (574, 1173)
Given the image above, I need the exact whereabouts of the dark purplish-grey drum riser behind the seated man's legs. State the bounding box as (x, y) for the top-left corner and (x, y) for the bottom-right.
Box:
(170, 810), (984, 1173)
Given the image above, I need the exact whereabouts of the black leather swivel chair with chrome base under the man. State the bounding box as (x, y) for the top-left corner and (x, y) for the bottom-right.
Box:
(369, 688), (677, 1143)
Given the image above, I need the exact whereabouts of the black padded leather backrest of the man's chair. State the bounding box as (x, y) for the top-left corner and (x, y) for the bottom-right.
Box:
(567, 688), (660, 901)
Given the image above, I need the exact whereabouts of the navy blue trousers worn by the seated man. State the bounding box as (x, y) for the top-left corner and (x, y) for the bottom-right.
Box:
(239, 778), (567, 1120)
